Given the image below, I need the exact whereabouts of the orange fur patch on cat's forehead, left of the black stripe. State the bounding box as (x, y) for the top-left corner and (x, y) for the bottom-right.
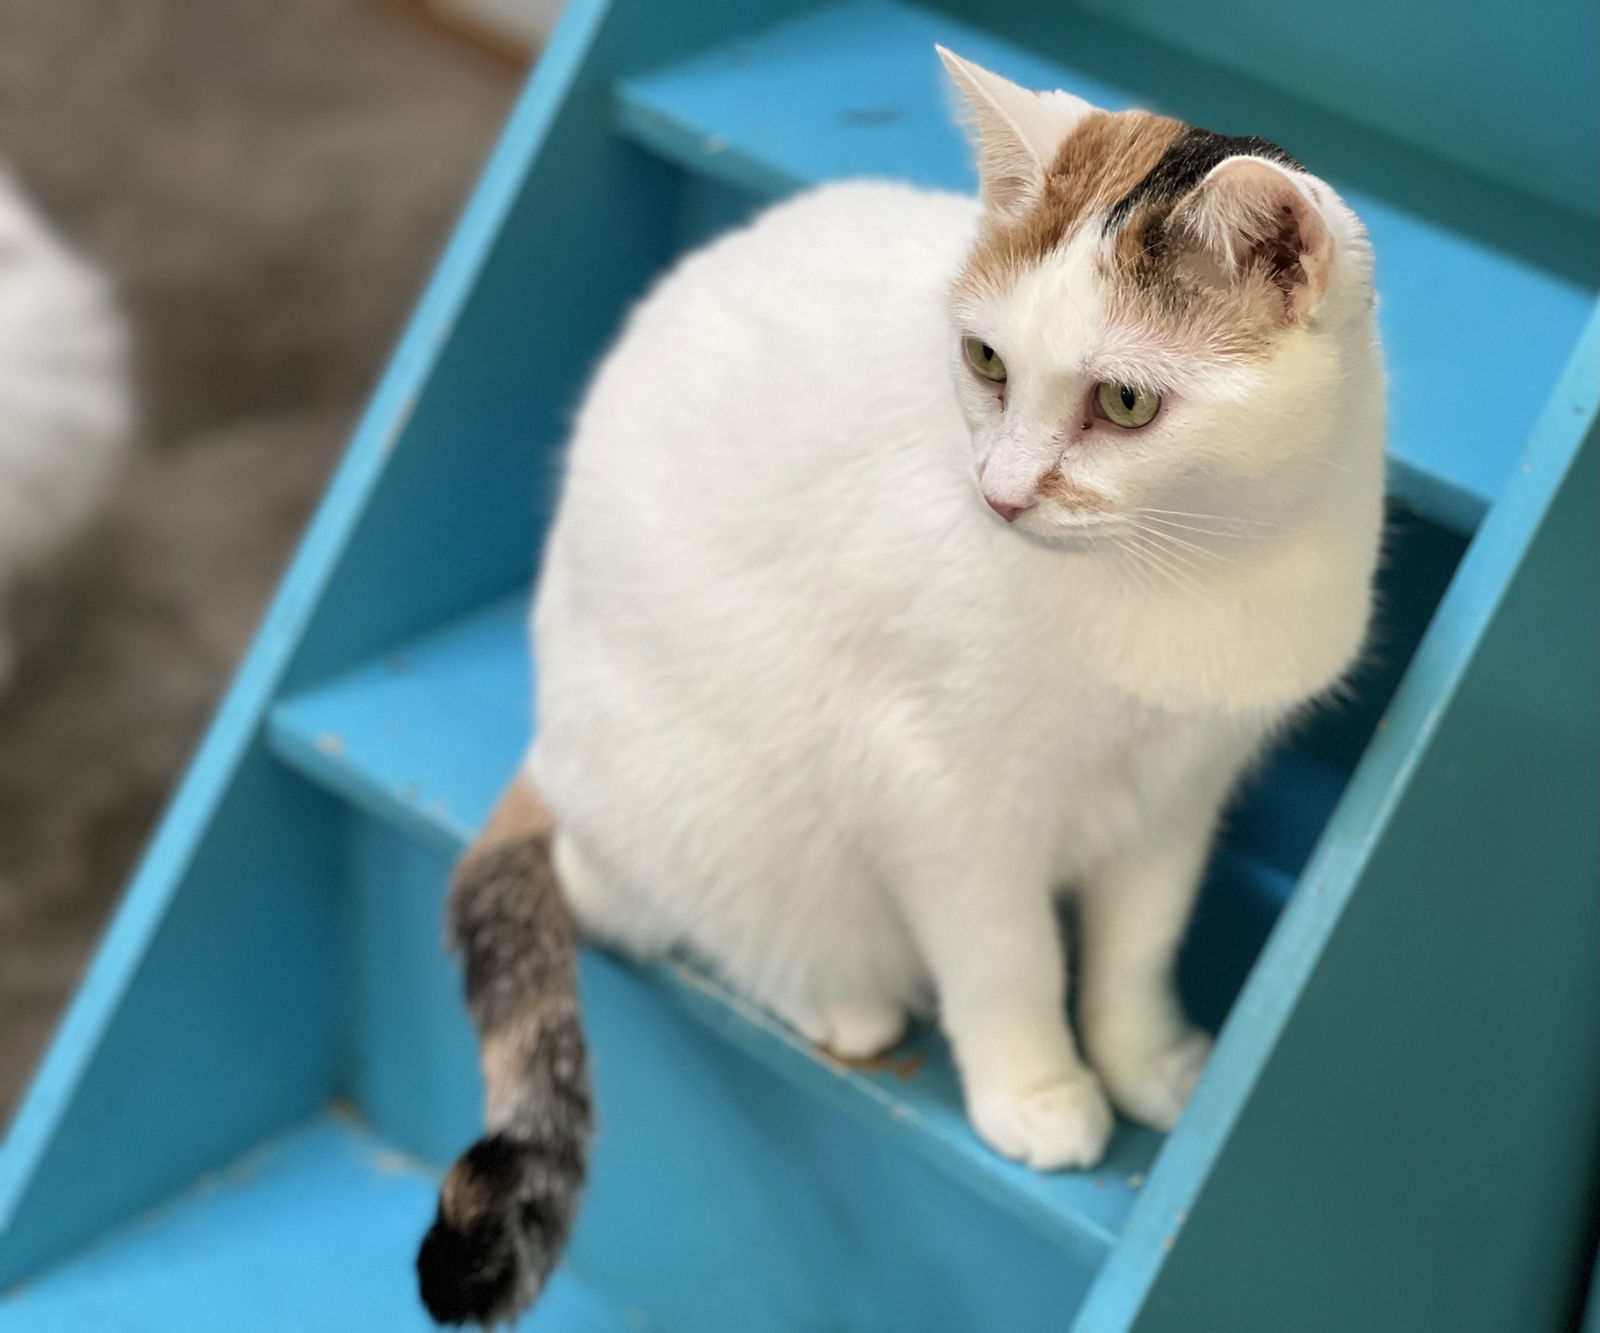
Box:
(955, 110), (1187, 296)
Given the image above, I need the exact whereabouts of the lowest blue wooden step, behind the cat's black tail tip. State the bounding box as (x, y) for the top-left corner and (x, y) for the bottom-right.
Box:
(0, 1114), (636, 1333)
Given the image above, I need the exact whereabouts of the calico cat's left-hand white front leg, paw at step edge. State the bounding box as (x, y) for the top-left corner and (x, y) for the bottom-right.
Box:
(901, 848), (1112, 1170)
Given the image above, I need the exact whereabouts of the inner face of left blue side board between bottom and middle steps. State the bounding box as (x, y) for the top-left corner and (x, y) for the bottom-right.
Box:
(0, 752), (339, 1288)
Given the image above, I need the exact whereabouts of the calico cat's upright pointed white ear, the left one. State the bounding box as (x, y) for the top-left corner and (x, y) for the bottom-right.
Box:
(934, 46), (1094, 214)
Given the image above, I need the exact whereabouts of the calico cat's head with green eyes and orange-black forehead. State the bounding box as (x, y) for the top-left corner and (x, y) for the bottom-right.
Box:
(939, 48), (1376, 544)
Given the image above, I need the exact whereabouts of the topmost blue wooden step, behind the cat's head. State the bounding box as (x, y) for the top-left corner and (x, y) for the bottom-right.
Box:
(604, 0), (1594, 531)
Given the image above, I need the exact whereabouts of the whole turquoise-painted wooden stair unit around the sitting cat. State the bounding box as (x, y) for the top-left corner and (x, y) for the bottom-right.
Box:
(0, 0), (1600, 1333)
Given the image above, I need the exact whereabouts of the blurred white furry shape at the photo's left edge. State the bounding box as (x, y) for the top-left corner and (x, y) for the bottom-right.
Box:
(0, 166), (131, 688)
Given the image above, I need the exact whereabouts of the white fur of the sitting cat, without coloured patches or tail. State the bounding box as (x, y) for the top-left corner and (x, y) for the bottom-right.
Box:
(530, 70), (1382, 1167)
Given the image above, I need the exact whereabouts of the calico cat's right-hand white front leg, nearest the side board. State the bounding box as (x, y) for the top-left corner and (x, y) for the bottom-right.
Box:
(1078, 810), (1216, 1130)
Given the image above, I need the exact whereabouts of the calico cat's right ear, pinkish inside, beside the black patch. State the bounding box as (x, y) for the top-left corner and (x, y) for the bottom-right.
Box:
(1170, 157), (1334, 323)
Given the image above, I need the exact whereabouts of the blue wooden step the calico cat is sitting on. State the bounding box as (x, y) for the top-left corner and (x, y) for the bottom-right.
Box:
(269, 595), (1171, 1264)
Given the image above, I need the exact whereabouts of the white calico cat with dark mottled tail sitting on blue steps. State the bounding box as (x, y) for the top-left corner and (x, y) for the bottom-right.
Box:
(419, 51), (1384, 1320)
